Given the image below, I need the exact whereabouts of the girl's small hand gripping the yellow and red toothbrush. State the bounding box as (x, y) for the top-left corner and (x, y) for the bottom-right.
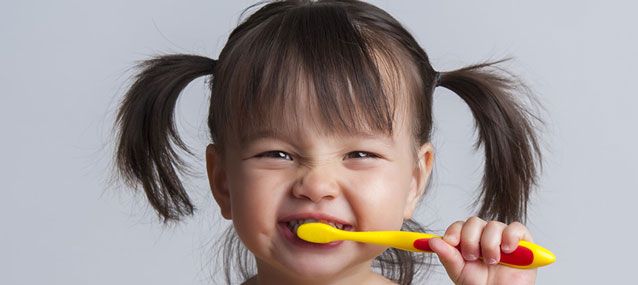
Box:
(429, 216), (538, 285)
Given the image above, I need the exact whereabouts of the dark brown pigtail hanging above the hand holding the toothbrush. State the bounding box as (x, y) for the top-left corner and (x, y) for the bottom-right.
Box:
(436, 60), (542, 223)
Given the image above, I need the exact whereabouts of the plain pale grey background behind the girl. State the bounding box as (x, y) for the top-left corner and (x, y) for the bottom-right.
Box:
(0, 0), (638, 284)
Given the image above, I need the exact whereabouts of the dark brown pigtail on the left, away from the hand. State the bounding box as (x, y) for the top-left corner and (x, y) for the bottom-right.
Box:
(115, 54), (216, 222)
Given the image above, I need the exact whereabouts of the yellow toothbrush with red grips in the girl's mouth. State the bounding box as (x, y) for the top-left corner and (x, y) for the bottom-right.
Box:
(297, 223), (556, 269)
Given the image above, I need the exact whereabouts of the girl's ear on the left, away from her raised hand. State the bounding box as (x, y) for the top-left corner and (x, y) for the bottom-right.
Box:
(206, 144), (232, 220)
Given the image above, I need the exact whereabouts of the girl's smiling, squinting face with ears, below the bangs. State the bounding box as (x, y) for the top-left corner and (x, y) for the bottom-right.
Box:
(207, 100), (433, 278)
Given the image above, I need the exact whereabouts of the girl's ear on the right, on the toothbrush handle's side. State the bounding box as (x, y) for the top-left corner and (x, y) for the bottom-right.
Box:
(403, 143), (434, 217)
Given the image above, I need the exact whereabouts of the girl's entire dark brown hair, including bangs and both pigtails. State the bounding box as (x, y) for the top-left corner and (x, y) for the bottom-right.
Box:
(110, 0), (542, 284)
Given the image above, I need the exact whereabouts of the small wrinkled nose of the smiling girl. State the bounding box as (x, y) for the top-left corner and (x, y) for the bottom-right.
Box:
(292, 167), (340, 203)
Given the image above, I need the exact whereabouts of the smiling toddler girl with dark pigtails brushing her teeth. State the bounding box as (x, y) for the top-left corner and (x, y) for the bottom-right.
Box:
(116, 0), (540, 284)
